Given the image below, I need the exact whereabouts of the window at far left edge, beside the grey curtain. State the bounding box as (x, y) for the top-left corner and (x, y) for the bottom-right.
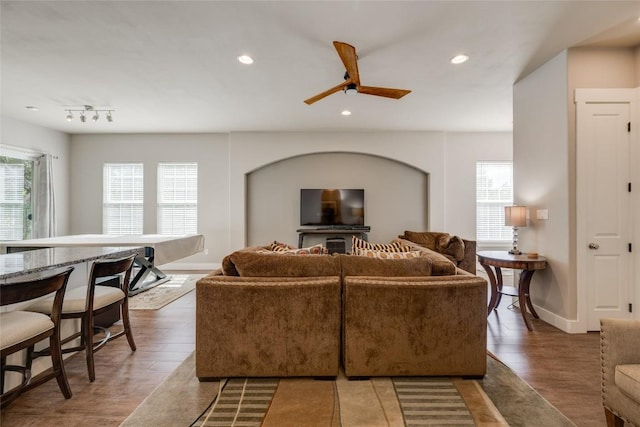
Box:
(0, 154), (34, 240)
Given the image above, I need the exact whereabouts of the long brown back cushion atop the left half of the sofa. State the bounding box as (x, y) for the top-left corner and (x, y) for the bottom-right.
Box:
(229, 250), (340, 277)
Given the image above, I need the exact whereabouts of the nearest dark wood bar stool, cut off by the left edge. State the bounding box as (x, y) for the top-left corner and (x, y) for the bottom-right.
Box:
(0, 267), (73, 407)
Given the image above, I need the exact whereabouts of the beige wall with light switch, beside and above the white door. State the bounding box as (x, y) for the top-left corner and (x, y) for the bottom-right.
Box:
(513, 48), (638, 330)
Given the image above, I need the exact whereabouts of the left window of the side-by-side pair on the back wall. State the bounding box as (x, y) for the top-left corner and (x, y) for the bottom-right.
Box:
(102, 163), (144, 234)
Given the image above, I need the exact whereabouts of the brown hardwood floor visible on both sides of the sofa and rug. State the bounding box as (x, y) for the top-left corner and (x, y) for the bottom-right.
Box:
(0, 280), (606, 427)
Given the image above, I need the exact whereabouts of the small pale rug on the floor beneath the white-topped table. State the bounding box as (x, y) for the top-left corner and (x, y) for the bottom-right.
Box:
(129, 274), (204, 310)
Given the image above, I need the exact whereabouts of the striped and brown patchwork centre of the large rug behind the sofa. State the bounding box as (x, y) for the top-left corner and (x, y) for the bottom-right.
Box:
(192, 376), (507, 427)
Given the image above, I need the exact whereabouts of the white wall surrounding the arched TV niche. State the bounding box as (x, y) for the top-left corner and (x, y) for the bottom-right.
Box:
(229, 132), (511, 250)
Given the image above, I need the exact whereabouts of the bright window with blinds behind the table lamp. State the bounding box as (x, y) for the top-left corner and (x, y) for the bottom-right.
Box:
(476, 162), (513, 242)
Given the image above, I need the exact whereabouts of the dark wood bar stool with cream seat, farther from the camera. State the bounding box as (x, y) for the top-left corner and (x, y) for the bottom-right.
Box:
(27, 255), (136, 382)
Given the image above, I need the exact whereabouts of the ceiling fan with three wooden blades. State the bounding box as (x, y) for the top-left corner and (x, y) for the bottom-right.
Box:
(304, 41), (411, 105)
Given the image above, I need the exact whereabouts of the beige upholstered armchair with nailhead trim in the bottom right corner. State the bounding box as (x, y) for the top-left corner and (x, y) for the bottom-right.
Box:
(600, 319), (640, 427)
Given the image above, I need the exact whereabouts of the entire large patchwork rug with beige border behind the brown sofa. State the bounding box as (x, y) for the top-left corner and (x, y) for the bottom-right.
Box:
(122, 354), (574, 427)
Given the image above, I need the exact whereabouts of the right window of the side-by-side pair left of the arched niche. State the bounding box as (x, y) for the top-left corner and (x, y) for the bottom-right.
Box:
(158, 163), (198, 234)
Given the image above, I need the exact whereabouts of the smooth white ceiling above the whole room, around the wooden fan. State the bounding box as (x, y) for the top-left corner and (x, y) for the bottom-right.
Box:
(0, 0), (640, 133)
